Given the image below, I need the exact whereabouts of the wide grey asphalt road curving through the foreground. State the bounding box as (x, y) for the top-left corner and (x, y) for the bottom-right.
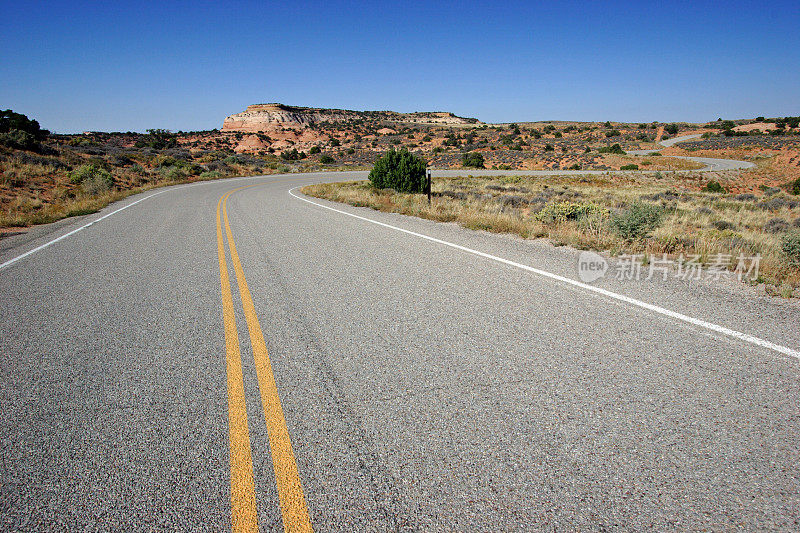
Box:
(0, 168), (800, 531)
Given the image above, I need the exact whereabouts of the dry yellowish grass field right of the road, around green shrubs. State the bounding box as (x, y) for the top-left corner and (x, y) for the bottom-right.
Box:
(302, 173), (800, 296)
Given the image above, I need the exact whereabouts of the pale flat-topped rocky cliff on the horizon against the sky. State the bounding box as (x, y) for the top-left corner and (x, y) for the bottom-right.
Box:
(222, 104), (480, 132)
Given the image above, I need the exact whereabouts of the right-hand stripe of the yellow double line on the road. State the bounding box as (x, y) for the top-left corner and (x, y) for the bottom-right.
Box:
(222, 189), (313, 532)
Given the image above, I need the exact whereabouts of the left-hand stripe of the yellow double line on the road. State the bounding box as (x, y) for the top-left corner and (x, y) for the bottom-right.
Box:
(217, 191), (258, 532)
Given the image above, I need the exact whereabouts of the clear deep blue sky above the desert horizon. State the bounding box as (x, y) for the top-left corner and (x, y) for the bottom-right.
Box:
(0, 0), (800, 132)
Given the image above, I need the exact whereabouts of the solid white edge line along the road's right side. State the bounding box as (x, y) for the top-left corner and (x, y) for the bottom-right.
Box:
(289, 187), (800, 359)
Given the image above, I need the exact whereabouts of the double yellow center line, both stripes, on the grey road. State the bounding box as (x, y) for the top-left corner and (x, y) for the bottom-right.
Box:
(217, 185), (312, 532)
